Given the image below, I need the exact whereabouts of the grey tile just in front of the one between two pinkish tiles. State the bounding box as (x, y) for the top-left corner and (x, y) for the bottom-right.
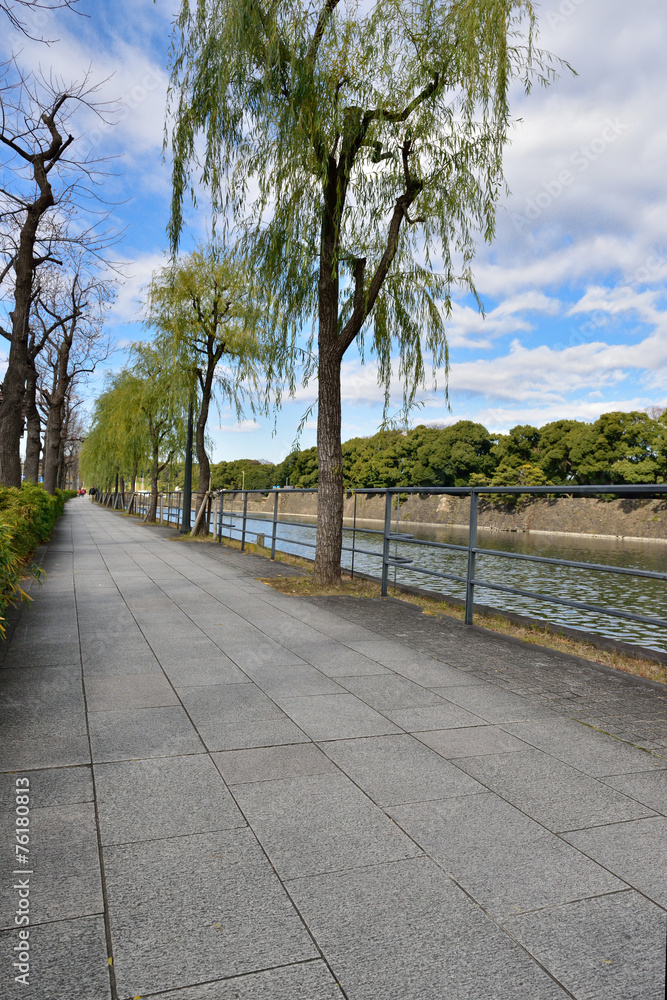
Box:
(389, 793), (624, 919)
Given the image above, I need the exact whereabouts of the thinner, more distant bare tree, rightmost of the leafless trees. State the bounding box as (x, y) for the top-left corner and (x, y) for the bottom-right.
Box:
(36, 271), (111, 493)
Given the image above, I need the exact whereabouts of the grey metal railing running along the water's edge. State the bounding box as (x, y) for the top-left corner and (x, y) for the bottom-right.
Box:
(98, 485), (667, 629)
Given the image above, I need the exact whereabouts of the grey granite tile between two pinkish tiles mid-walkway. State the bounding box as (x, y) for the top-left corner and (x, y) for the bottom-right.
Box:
(323, 735), (485, 806)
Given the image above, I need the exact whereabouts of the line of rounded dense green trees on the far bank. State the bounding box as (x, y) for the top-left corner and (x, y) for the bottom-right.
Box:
(209, 410), (667, 489)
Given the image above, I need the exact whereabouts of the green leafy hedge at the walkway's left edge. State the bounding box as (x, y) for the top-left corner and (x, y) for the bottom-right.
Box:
(0, 483), (76, 636)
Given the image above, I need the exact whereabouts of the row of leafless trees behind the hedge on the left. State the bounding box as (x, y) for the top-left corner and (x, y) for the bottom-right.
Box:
(0, 0), (117, 492)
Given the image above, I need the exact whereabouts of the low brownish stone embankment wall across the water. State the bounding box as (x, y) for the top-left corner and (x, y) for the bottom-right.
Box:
(235, 491), (667, 542)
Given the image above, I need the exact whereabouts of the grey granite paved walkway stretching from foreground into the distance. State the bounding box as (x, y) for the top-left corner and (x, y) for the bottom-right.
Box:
(0, 499), (667, 1000)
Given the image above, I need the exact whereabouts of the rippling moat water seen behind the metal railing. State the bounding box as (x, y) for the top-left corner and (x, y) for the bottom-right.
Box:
(223, 511), (667, 651)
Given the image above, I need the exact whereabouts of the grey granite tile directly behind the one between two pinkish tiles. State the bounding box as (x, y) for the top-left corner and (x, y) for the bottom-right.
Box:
(281, 694), (400, 742)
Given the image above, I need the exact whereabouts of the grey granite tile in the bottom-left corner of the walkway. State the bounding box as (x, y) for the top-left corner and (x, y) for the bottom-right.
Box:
(0, 915), (111, 1000)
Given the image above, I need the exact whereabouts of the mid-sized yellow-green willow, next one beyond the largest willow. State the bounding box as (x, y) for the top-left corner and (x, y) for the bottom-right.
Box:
(146, 246), (263, 532)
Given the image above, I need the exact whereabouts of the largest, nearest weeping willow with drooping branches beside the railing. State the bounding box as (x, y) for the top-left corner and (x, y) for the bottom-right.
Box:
(170, 0), (564, 584)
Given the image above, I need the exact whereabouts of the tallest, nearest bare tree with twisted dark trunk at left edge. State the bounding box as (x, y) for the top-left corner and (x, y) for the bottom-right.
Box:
(0, 60), (114, 486)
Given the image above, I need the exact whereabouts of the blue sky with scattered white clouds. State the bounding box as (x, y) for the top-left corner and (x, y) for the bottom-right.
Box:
(0, 0), (667, 461)
